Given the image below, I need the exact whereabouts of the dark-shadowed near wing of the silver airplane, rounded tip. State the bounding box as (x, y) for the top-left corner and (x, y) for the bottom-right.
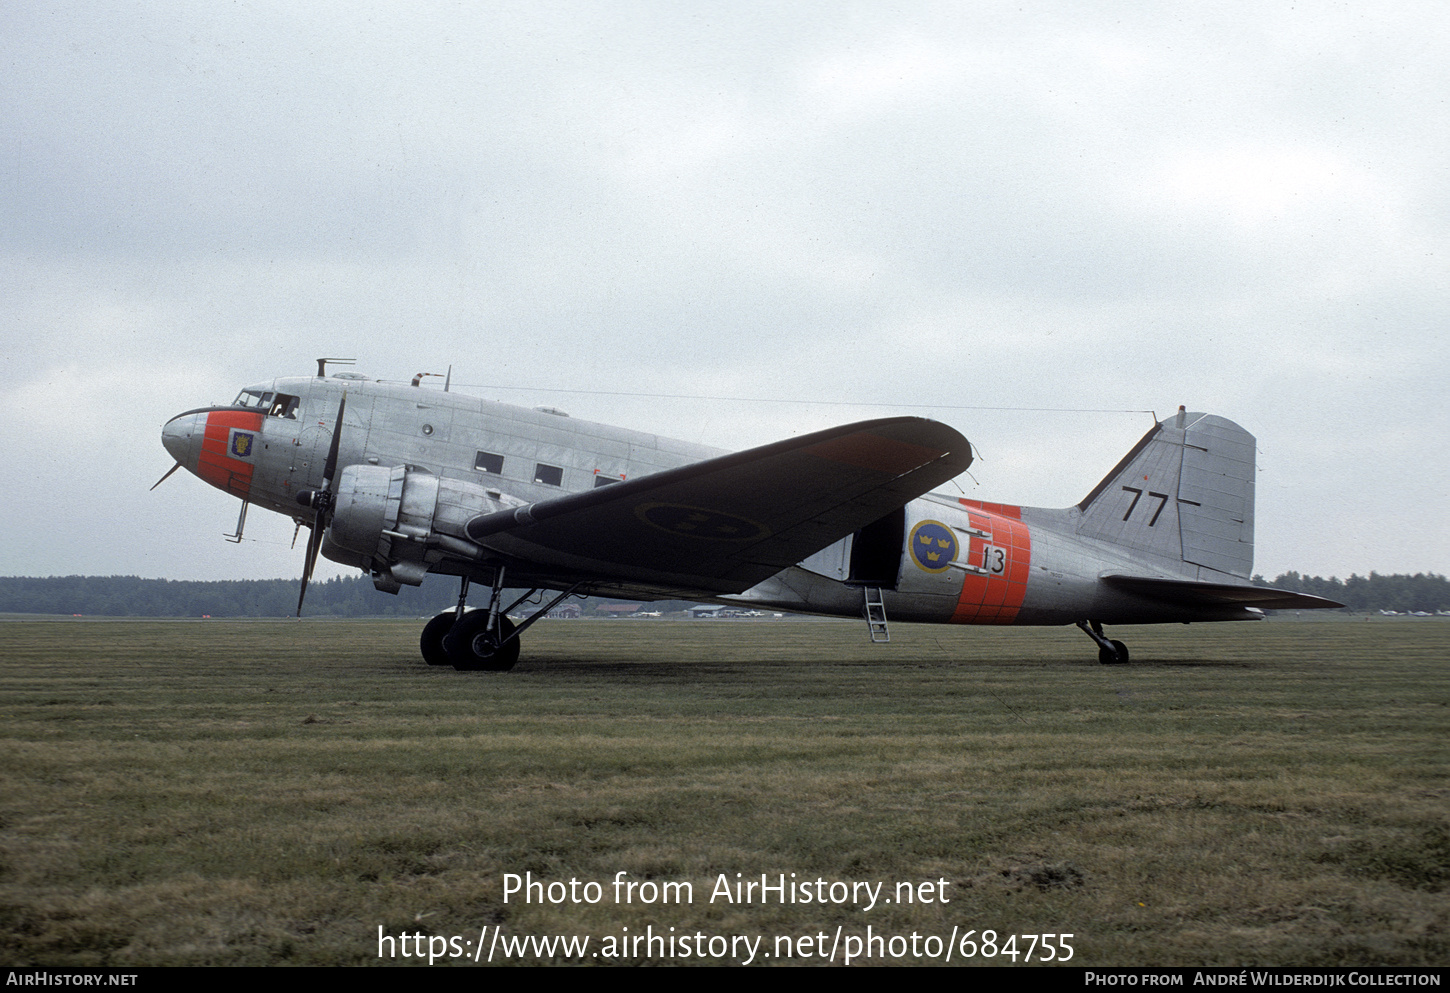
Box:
(464, 417), (972, 593)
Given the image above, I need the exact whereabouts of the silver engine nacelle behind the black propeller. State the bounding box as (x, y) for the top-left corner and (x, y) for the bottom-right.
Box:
(322, 465), (523, 593)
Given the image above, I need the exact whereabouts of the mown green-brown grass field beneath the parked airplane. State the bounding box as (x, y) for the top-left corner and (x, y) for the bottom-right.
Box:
(0, 618), (1450, 965)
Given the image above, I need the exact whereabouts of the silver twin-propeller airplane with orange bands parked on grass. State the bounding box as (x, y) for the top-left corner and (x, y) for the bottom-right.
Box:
(152, 358), (1343, 671)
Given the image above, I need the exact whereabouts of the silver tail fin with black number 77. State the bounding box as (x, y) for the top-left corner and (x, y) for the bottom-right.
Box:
(1077, 407), (1254, 580)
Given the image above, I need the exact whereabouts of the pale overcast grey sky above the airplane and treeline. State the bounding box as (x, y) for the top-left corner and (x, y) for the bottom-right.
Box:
(0, 0), (1450, 580)
